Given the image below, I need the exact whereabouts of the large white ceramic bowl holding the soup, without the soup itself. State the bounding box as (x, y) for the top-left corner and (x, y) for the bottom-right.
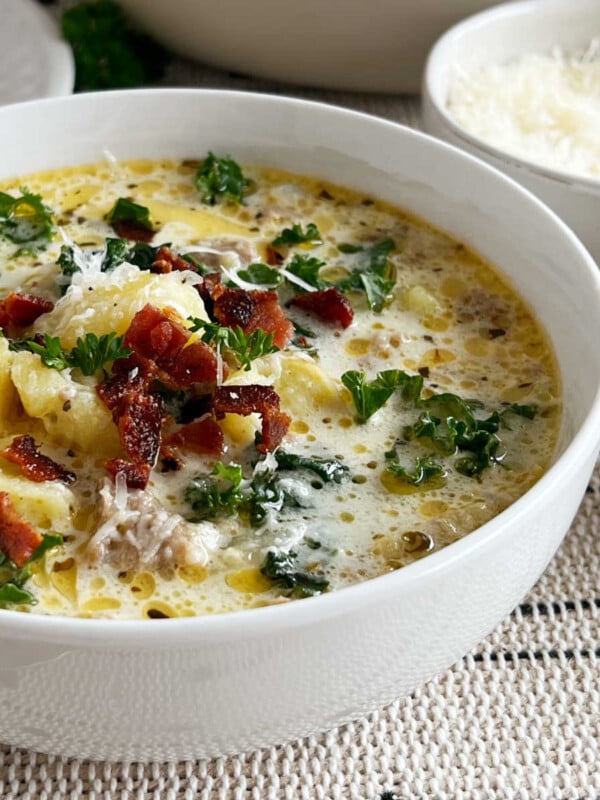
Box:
(0, 90), (600, 760)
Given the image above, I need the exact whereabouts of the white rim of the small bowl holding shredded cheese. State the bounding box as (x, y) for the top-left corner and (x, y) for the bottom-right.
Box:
(423, 0), (600, 194)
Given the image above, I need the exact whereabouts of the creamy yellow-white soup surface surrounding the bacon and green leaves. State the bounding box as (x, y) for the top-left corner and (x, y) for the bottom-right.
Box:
(0, 156), (560, 618)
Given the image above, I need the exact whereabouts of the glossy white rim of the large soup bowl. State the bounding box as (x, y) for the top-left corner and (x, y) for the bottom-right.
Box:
(0, 88), (600, 650)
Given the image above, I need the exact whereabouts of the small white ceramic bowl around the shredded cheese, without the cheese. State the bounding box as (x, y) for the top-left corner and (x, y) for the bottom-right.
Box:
(423, 0), (600, 261)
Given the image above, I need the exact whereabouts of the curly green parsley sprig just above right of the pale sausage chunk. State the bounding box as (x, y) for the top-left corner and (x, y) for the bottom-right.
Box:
(184, 461), (244, 522)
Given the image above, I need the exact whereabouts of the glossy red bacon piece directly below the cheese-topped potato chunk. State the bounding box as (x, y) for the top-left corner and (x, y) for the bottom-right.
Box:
(123, 304), (218, 389)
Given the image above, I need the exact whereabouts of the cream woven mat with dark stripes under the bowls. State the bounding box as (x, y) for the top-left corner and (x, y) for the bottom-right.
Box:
(0, 0), (600, 800)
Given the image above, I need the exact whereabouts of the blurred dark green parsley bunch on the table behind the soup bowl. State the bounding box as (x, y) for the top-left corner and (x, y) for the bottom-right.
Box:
(62, 0), (169, 92)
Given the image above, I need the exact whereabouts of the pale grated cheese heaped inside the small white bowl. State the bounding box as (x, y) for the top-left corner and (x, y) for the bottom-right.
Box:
(447, 38), (600, 178)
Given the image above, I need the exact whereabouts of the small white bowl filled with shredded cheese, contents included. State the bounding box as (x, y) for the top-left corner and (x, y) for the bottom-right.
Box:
(423, 0), (600, 260)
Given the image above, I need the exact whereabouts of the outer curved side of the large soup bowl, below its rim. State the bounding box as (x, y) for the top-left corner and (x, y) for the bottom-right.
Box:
(0, 446), (593, 760)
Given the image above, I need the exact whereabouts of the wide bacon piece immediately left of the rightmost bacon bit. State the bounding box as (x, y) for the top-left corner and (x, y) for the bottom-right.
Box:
(211, 284), (294, 349)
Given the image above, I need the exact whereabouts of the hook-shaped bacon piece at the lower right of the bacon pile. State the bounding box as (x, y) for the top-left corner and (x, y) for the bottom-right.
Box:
(213, 384), (292, 453)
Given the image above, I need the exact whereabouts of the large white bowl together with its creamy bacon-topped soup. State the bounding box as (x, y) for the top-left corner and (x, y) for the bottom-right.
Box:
(0, 91), (598, 758)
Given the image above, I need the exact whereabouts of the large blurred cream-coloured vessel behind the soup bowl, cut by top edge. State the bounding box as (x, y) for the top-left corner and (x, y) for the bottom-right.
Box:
(121, 0), (495, 92)
